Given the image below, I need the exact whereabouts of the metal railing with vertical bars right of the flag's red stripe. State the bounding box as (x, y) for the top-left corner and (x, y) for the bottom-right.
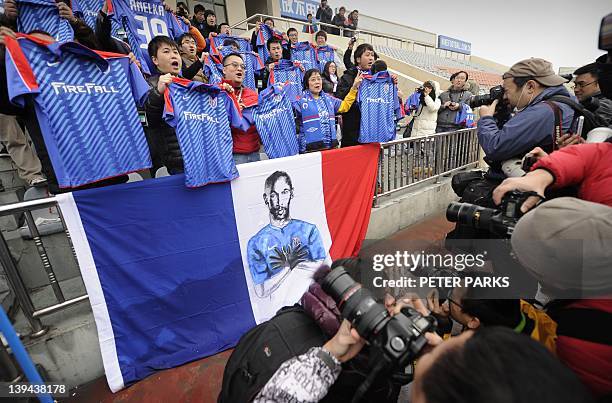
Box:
(374, 129), (480, 205)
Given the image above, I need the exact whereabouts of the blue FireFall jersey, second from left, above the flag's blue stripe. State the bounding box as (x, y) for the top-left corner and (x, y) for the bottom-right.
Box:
(164, 78), (241, 187)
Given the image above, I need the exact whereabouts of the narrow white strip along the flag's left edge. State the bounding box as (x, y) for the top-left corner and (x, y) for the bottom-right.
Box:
(56, 193), (124, 392)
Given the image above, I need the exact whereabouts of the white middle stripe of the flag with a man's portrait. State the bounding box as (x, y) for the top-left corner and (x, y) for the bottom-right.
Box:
(231, 153), (332, 323)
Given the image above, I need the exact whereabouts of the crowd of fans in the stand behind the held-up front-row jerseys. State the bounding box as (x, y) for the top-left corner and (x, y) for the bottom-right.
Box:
(1, 0), (373, 193)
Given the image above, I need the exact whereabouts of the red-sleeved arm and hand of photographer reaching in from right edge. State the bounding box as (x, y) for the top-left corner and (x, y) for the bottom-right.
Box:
(493, 142), (612, 212)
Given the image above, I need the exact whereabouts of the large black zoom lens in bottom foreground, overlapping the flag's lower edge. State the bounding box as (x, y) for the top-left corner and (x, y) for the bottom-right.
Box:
(321, 267), (389, 340)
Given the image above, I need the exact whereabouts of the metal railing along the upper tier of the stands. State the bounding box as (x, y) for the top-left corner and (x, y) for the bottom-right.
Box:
(231, 14), (435, 49)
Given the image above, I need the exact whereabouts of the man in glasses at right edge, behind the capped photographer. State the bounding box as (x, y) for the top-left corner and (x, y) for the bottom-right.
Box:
(574, 63), (612, 126)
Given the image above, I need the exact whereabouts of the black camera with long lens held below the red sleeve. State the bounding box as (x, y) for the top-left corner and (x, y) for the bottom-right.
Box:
(446, 190), (538, 238)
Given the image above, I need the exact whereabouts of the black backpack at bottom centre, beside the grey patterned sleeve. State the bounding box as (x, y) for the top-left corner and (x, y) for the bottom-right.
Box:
(217, 305), (328, 403)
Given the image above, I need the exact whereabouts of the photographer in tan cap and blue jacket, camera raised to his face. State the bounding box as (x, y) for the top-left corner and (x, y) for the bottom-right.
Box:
(478, 58), (574, 179)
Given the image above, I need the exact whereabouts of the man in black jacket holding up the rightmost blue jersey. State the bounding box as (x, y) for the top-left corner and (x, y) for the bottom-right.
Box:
(336, 43), (374, 147)
